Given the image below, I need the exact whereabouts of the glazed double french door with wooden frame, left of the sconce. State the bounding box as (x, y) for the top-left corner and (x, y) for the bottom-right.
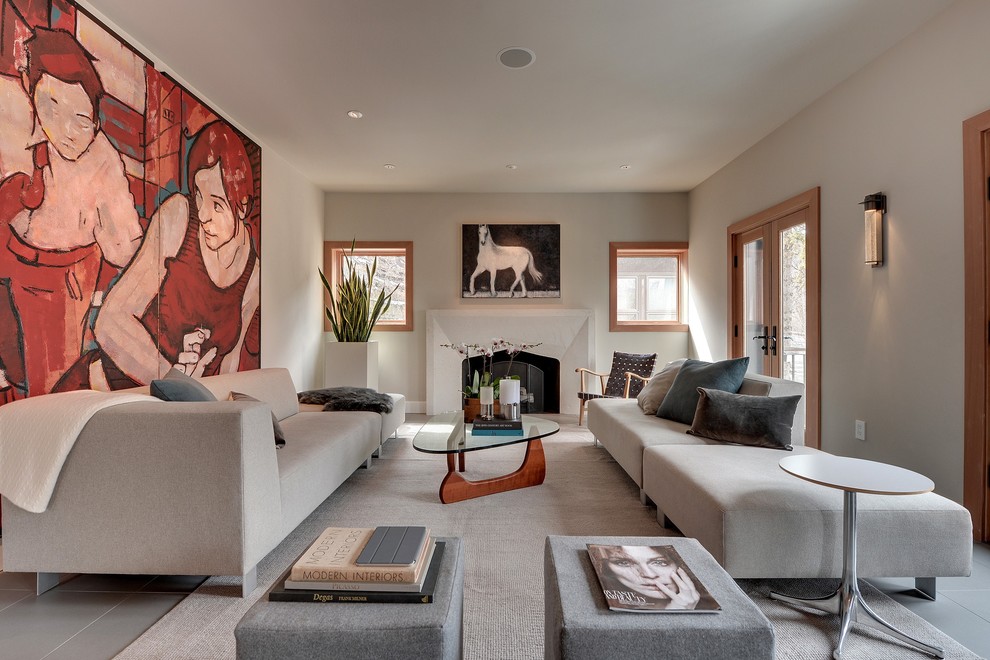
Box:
(729, 188), (820, 447)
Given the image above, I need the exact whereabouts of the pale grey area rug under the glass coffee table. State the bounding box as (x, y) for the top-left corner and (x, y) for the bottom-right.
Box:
(117, 416), (977, 660)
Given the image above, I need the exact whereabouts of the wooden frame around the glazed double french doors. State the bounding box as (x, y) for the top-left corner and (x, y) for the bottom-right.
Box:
(726, 187), (821, 448)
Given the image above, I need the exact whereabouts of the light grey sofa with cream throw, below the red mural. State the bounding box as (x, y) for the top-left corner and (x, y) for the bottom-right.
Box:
(3, 369), (405, 595)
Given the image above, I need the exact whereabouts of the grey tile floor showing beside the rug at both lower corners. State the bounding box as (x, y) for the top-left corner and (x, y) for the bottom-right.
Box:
(0, 544), (990, 660)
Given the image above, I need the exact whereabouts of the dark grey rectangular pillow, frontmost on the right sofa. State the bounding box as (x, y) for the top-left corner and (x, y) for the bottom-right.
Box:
(688, 387), (801, 451)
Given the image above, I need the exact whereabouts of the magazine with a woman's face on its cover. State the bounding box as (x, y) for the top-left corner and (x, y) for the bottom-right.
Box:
(588, 543), (722, 612)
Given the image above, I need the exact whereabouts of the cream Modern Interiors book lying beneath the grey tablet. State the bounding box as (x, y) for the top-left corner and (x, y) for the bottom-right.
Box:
(289, 527), (430, 583)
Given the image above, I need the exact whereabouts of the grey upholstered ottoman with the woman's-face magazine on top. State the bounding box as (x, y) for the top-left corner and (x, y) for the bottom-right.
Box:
(543, 536), (774, 660)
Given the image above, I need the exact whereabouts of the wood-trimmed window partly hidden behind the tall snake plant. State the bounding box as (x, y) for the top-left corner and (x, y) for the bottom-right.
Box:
(323, 241), (413, 332)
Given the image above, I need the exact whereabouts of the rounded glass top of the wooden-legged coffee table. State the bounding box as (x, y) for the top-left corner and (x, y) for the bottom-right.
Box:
(413, 410), (560, 454)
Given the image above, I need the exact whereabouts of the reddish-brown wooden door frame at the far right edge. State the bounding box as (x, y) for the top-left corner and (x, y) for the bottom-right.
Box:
(963, 110), (990, 541)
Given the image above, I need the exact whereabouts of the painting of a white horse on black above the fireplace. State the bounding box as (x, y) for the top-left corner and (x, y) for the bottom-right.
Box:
(461, 224), (560, 298)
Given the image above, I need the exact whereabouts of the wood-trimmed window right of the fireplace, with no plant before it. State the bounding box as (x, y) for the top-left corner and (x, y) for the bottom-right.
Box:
(608, 243), (688, 332)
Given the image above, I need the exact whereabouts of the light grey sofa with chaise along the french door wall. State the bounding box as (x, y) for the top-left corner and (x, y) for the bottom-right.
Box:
(588, 375), (973, 597)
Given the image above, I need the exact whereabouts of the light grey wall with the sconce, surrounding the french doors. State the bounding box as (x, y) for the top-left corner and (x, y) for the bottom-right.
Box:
(690, 1), (990, 501)
